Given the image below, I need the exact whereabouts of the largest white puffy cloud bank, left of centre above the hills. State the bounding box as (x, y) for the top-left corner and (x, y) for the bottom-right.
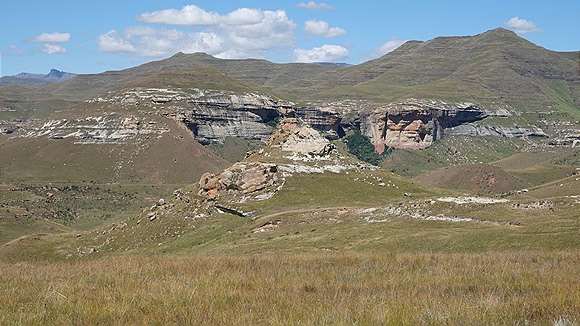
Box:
(98, 6), (296, 59)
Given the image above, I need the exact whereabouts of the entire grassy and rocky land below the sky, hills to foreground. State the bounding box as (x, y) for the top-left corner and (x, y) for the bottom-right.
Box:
(0, 28), (580, 325)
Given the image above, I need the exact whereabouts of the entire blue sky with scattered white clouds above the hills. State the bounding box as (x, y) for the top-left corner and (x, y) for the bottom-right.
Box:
(0, 0), (580, 76)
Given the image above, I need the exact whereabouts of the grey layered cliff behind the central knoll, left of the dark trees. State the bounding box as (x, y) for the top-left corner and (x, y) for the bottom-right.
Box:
(99, 88), (344, 145)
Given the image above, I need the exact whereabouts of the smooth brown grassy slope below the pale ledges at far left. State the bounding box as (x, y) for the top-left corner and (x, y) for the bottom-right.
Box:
(0, 117), (229, 183)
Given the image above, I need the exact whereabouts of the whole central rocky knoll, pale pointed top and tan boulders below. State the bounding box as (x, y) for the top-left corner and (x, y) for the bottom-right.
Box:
(199, 118), (362, 201)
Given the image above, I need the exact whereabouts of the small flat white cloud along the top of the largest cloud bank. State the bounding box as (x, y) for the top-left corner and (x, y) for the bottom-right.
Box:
(136, 5), (220, 26)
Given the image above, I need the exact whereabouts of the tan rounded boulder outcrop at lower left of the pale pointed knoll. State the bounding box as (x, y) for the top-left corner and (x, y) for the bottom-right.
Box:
(199, 162), (279, 198)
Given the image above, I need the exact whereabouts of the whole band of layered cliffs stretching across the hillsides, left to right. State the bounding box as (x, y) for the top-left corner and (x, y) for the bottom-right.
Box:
(19, 88), (556, 153)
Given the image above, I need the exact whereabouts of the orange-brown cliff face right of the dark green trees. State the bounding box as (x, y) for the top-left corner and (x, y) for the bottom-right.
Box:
(361, 100), (487, 153)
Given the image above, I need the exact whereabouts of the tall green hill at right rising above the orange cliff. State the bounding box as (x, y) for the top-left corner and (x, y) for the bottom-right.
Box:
(294, 29), (580, 113)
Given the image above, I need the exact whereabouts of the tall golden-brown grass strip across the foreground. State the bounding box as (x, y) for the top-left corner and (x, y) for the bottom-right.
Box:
(0, 252), (580, 325)
